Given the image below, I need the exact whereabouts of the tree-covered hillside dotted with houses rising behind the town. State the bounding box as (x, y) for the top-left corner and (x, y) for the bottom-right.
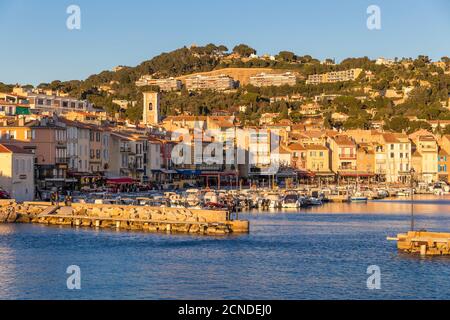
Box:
(0, 44), (450, 131)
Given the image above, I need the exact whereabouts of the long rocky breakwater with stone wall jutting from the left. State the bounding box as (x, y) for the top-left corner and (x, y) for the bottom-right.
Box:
(0, 200), (249, 235)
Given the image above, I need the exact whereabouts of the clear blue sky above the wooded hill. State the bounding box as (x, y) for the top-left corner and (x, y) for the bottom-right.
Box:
(0, 0), (450, 84)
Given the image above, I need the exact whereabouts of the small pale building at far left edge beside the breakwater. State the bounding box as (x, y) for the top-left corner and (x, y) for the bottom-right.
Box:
(0, 144), (35, 202)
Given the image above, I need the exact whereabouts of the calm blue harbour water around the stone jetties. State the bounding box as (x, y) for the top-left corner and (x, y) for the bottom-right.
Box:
(0, 197), (450, 299)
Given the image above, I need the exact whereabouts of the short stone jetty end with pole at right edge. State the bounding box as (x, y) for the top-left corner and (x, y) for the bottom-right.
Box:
(387, 231), (450, 256)
